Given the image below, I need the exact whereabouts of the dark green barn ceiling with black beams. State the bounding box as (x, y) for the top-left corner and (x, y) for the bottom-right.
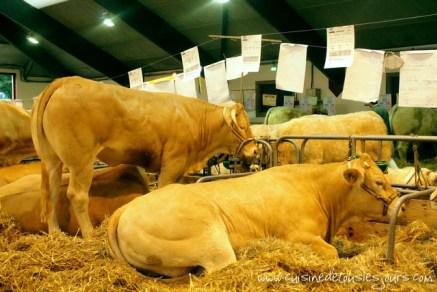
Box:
(0, 0), (437, 92)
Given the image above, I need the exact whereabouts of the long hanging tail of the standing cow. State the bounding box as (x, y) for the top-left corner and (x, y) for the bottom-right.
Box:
(31, 78), (65, 222)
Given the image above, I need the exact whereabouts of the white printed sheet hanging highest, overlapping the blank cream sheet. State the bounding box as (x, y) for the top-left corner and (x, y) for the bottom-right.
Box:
(325, 25), (355, 68)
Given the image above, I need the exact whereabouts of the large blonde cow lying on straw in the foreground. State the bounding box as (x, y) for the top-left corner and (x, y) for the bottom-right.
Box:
(108, 154), (397, 277)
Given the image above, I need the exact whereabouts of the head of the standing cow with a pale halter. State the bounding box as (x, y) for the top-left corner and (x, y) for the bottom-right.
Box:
(223, 103), (258, 158)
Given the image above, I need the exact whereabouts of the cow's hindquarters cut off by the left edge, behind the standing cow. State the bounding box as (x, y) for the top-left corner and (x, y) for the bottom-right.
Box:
(0, 102), (36, 166)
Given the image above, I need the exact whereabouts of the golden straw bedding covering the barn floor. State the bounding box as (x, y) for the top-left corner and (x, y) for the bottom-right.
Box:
(0, 216), (437, 291)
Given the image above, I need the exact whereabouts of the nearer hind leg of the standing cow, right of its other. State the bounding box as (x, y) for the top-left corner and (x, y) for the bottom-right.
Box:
(67, 164), (93, 238)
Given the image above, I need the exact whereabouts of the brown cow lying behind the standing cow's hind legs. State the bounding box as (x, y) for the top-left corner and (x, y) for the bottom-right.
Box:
(0, 165), (148, 235)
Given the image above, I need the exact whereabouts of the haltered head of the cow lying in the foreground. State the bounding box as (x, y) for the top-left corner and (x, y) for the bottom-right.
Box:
(343, 153), (398, 218)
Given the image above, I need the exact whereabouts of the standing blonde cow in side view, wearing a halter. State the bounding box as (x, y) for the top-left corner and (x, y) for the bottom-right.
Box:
(32, 77), (257, 237)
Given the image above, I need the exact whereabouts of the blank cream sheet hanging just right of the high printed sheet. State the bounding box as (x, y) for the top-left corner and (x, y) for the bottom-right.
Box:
(341, 49), (384, 102)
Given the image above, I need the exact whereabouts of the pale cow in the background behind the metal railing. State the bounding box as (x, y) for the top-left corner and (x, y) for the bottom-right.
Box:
(251, 111), (392, 165)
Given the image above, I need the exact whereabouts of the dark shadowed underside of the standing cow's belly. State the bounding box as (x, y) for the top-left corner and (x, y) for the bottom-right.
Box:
(97, 148), (161, 171)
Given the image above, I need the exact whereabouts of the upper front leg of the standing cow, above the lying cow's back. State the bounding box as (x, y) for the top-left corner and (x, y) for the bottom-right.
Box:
(158, 155), (187, 188)
